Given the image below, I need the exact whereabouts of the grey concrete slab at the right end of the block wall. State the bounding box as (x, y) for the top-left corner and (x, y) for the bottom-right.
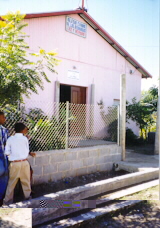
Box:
(117, 151), (159, 172)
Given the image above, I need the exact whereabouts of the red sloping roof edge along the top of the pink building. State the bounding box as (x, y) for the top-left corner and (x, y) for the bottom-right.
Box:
(25, 9), (152, 78)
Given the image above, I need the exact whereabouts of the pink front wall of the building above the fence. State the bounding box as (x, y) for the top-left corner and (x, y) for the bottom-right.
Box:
(25, 15), (141, 132)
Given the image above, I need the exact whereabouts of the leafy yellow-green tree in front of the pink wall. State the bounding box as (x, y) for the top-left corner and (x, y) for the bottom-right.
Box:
(0, 11), (60, 105)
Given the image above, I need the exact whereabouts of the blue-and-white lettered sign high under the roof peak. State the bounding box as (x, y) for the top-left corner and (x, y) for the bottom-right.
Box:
(66, 16), (87, 38)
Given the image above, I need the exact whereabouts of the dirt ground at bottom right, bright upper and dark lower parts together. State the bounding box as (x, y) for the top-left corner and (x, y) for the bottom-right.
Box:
(75, 186), (160, 228)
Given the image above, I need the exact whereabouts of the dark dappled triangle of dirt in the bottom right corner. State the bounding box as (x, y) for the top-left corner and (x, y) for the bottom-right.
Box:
(79, 201), (160, 228)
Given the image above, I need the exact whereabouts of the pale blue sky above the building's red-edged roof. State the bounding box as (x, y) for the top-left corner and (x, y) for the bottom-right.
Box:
(0, 0), (160, 90)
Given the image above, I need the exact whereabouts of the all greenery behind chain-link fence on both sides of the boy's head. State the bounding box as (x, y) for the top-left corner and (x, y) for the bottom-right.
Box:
(0, 105), (66, 151)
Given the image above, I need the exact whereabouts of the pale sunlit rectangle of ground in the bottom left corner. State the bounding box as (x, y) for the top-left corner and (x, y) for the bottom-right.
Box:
(0, 208), (32, 228)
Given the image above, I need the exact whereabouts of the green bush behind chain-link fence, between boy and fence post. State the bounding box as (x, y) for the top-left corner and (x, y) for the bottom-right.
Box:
(27, 108), (65, 151)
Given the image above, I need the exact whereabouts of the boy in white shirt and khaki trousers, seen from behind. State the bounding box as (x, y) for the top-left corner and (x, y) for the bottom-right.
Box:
(3, 123), (31, 205)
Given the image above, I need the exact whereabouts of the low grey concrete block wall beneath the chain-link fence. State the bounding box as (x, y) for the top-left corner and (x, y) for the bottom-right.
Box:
(28, 144), (121, 185)
